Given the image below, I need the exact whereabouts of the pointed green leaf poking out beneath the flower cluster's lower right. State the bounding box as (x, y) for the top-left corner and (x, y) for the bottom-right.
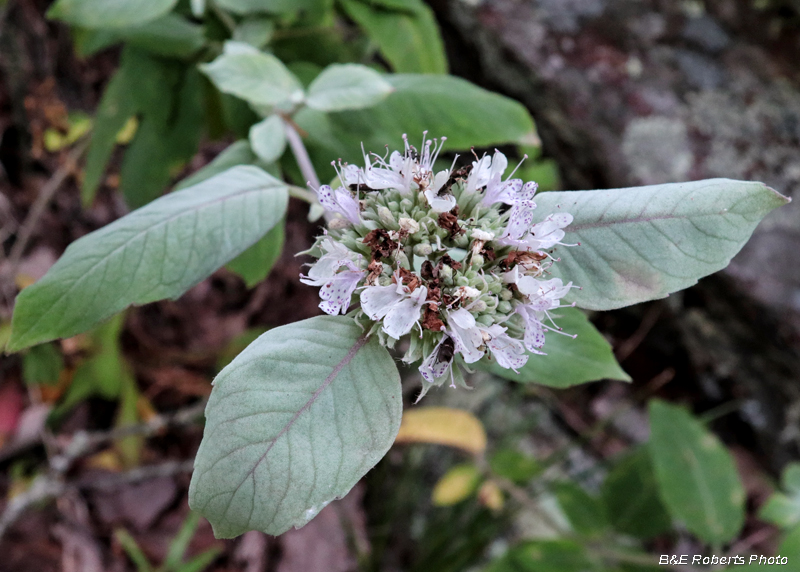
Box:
(477, 308), (631, 388)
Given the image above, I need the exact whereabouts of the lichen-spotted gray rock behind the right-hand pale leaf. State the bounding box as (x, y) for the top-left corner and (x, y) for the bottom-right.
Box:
(434, 0), (800, 470)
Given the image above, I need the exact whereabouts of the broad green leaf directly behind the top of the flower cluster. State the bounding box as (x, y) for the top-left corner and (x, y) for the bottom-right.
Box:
(294, 74), (534, 164)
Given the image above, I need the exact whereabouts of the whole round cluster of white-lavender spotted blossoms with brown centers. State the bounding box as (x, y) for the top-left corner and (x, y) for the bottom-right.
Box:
(301, 137), (573, 397)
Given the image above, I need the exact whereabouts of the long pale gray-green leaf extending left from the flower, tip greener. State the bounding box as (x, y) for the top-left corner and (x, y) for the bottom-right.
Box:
(9, 167), (288, 350)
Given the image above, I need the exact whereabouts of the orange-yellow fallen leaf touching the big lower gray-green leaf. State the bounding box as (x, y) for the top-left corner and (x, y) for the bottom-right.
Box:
(395, 407), (486, 454)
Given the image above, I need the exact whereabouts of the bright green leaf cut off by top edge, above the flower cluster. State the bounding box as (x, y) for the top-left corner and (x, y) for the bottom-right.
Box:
(341, 0), (447, 74)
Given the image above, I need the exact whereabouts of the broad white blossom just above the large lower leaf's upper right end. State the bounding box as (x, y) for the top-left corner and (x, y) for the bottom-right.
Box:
(361, 276), (428, 339)
